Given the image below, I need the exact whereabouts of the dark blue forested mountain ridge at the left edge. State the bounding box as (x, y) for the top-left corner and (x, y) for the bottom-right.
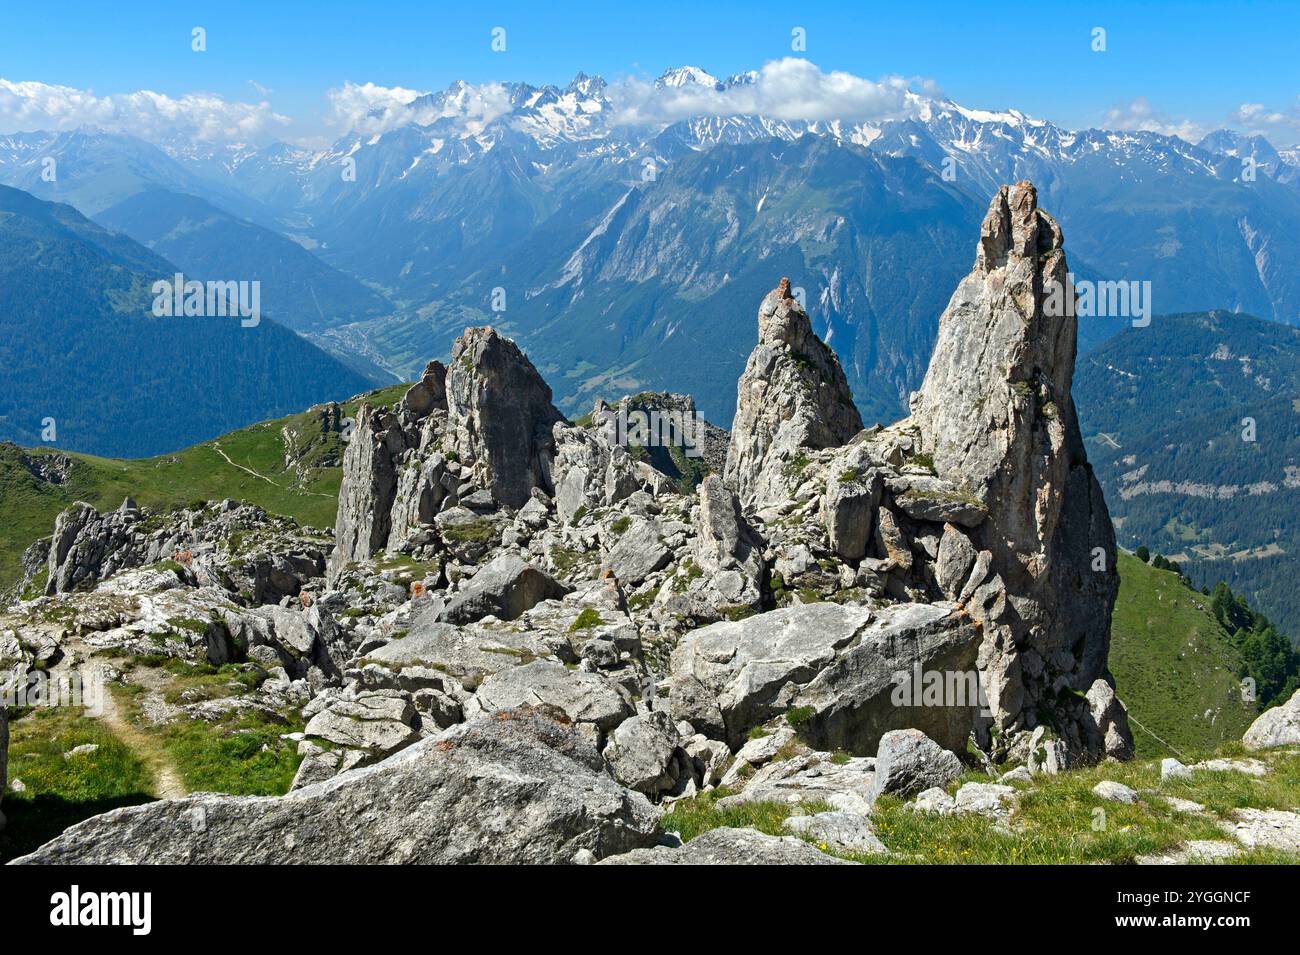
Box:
(0, 186), (371, 455)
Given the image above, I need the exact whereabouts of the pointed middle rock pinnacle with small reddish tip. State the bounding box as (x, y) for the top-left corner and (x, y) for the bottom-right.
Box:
(724, 278), (862, 507)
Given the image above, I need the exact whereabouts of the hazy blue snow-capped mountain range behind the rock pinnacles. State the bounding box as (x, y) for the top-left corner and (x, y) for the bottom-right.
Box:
(0, 68), (1300, 424)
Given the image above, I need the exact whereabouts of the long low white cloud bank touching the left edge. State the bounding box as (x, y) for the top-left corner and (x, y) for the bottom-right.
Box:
(0, 79), (290, 143)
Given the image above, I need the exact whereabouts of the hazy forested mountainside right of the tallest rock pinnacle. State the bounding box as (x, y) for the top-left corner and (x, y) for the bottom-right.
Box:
(1075, 312), (1300, 635)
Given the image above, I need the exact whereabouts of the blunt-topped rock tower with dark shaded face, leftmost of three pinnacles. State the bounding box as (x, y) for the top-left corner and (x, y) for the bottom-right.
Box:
(447, 326), (564, 508)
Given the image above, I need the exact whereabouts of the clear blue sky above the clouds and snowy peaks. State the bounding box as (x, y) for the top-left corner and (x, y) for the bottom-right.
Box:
(0, 0), (1300, 142)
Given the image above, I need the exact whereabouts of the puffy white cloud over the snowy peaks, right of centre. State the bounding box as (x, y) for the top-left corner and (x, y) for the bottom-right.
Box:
(610, 57), (914, 123)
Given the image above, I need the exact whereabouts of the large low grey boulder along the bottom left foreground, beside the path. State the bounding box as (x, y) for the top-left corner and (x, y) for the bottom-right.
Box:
(17, 708), (659, 865)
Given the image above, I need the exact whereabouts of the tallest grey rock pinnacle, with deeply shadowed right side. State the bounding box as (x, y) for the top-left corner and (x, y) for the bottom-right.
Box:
(911, 182), (1132, 756)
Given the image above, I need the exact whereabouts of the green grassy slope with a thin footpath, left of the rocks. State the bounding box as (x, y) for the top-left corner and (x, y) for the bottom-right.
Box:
(0, 385), (410, 591)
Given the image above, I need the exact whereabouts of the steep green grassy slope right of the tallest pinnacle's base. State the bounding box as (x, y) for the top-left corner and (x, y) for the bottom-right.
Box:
(1110, 552), (1257, 758)
